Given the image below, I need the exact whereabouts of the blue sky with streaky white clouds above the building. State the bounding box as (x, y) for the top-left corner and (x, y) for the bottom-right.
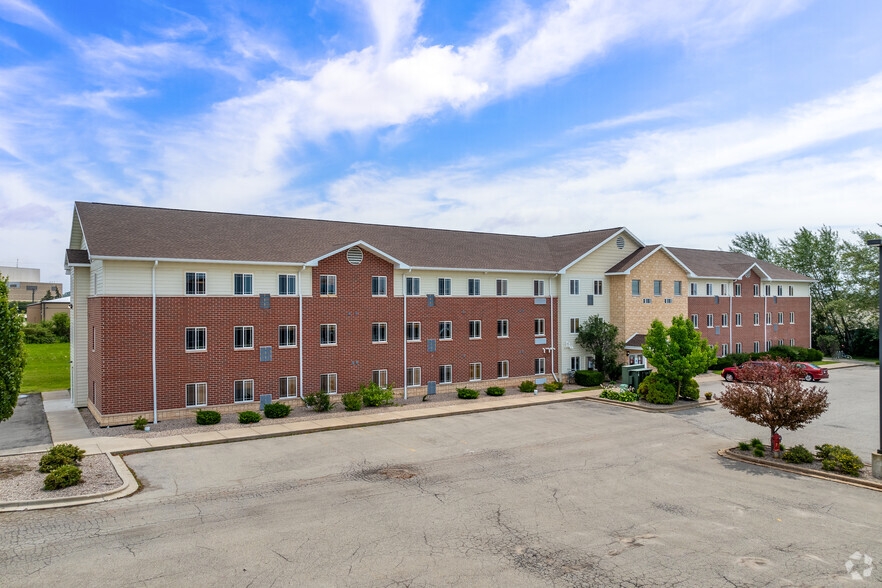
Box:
(0, 0), (882, 283)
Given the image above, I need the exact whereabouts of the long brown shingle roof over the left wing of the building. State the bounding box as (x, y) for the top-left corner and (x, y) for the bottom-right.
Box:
(76, 202), (620, 271)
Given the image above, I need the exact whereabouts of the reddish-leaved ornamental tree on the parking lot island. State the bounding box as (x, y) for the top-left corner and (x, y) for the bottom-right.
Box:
(719, 360), (830, 454)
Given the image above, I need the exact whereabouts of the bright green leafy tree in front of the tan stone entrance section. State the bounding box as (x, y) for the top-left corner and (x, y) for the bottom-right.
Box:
(643, 316), (717, 396)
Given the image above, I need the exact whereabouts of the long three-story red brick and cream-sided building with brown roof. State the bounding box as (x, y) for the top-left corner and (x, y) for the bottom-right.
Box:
(65, 203), (810, 425)
